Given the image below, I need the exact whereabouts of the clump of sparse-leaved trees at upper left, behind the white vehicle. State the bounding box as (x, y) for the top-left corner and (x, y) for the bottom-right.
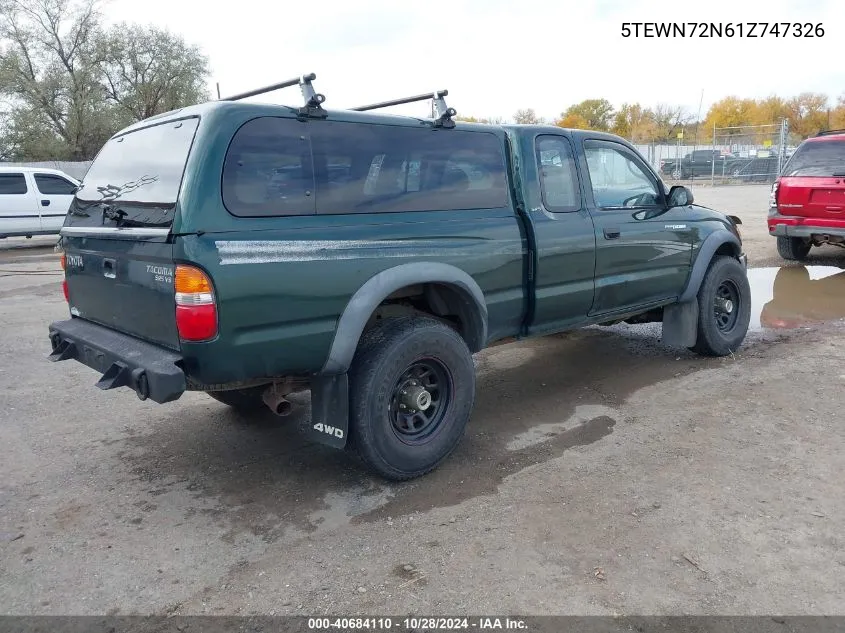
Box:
(0, 0), (208, 160)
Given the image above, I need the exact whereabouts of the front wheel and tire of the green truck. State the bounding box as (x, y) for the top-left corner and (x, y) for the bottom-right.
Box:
(690, 256), (751, 356)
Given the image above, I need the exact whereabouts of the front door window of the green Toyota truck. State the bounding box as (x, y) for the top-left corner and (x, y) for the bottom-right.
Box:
(584, 141), (660, 208)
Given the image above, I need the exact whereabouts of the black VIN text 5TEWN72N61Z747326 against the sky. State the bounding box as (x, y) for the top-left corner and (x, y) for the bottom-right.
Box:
(622, 22), (824, 38)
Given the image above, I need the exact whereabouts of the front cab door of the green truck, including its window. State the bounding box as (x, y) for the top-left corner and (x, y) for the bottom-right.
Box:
(582, 139), (692, 314)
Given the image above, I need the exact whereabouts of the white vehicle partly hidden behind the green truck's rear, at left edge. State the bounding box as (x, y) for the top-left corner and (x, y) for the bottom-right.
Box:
(0, 166), (79, 239)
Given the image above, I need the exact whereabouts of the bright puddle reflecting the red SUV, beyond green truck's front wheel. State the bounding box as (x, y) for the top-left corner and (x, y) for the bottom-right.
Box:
(748, 266), (845, 330)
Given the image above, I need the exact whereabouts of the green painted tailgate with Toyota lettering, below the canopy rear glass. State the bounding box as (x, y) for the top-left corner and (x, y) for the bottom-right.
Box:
(63, 237), (179, 349)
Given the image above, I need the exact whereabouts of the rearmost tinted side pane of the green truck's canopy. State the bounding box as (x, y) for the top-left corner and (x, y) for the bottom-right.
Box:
(223, 117), (314, 217)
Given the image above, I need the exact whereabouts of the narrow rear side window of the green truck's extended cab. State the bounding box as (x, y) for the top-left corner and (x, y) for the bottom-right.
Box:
(536, 135), (581, 211)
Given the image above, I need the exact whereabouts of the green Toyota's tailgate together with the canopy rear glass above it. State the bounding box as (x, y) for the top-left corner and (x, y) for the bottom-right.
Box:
(61, 117), (199, 349)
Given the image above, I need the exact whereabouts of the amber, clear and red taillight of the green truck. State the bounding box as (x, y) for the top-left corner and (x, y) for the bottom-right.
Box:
(174, 264), (217, 341)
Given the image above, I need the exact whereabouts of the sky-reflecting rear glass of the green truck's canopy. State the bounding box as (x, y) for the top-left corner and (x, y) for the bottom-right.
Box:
(66, 117), (199, 227)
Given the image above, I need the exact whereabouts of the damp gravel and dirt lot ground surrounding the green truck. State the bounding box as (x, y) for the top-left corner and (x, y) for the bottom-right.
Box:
(0, 186), (845, 614)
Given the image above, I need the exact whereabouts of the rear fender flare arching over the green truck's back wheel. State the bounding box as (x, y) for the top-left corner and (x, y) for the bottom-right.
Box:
(320, 262), (487, 375)
